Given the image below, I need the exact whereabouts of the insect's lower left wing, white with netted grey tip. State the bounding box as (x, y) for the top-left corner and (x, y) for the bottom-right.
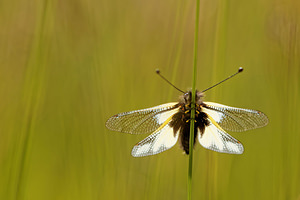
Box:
(131, 121), (178, 157)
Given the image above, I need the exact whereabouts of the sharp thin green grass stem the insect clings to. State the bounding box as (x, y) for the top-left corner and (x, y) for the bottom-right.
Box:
(188, 0), (200, 200)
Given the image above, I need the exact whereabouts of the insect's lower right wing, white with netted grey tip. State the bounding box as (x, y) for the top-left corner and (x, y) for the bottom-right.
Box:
(198, 116), (244, 154)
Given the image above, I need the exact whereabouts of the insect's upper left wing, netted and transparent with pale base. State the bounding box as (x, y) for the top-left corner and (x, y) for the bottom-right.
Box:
(106, 102), (179, 134)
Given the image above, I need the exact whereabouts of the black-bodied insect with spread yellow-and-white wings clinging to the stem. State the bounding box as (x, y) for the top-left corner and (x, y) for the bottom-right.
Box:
(106, 68), (268, 157)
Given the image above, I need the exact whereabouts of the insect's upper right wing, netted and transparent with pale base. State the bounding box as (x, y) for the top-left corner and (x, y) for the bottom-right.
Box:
(202, 102), (269, 131)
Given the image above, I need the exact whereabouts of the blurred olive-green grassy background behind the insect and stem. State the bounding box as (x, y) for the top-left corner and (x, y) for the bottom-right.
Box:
(0, 0), (300, 200)
